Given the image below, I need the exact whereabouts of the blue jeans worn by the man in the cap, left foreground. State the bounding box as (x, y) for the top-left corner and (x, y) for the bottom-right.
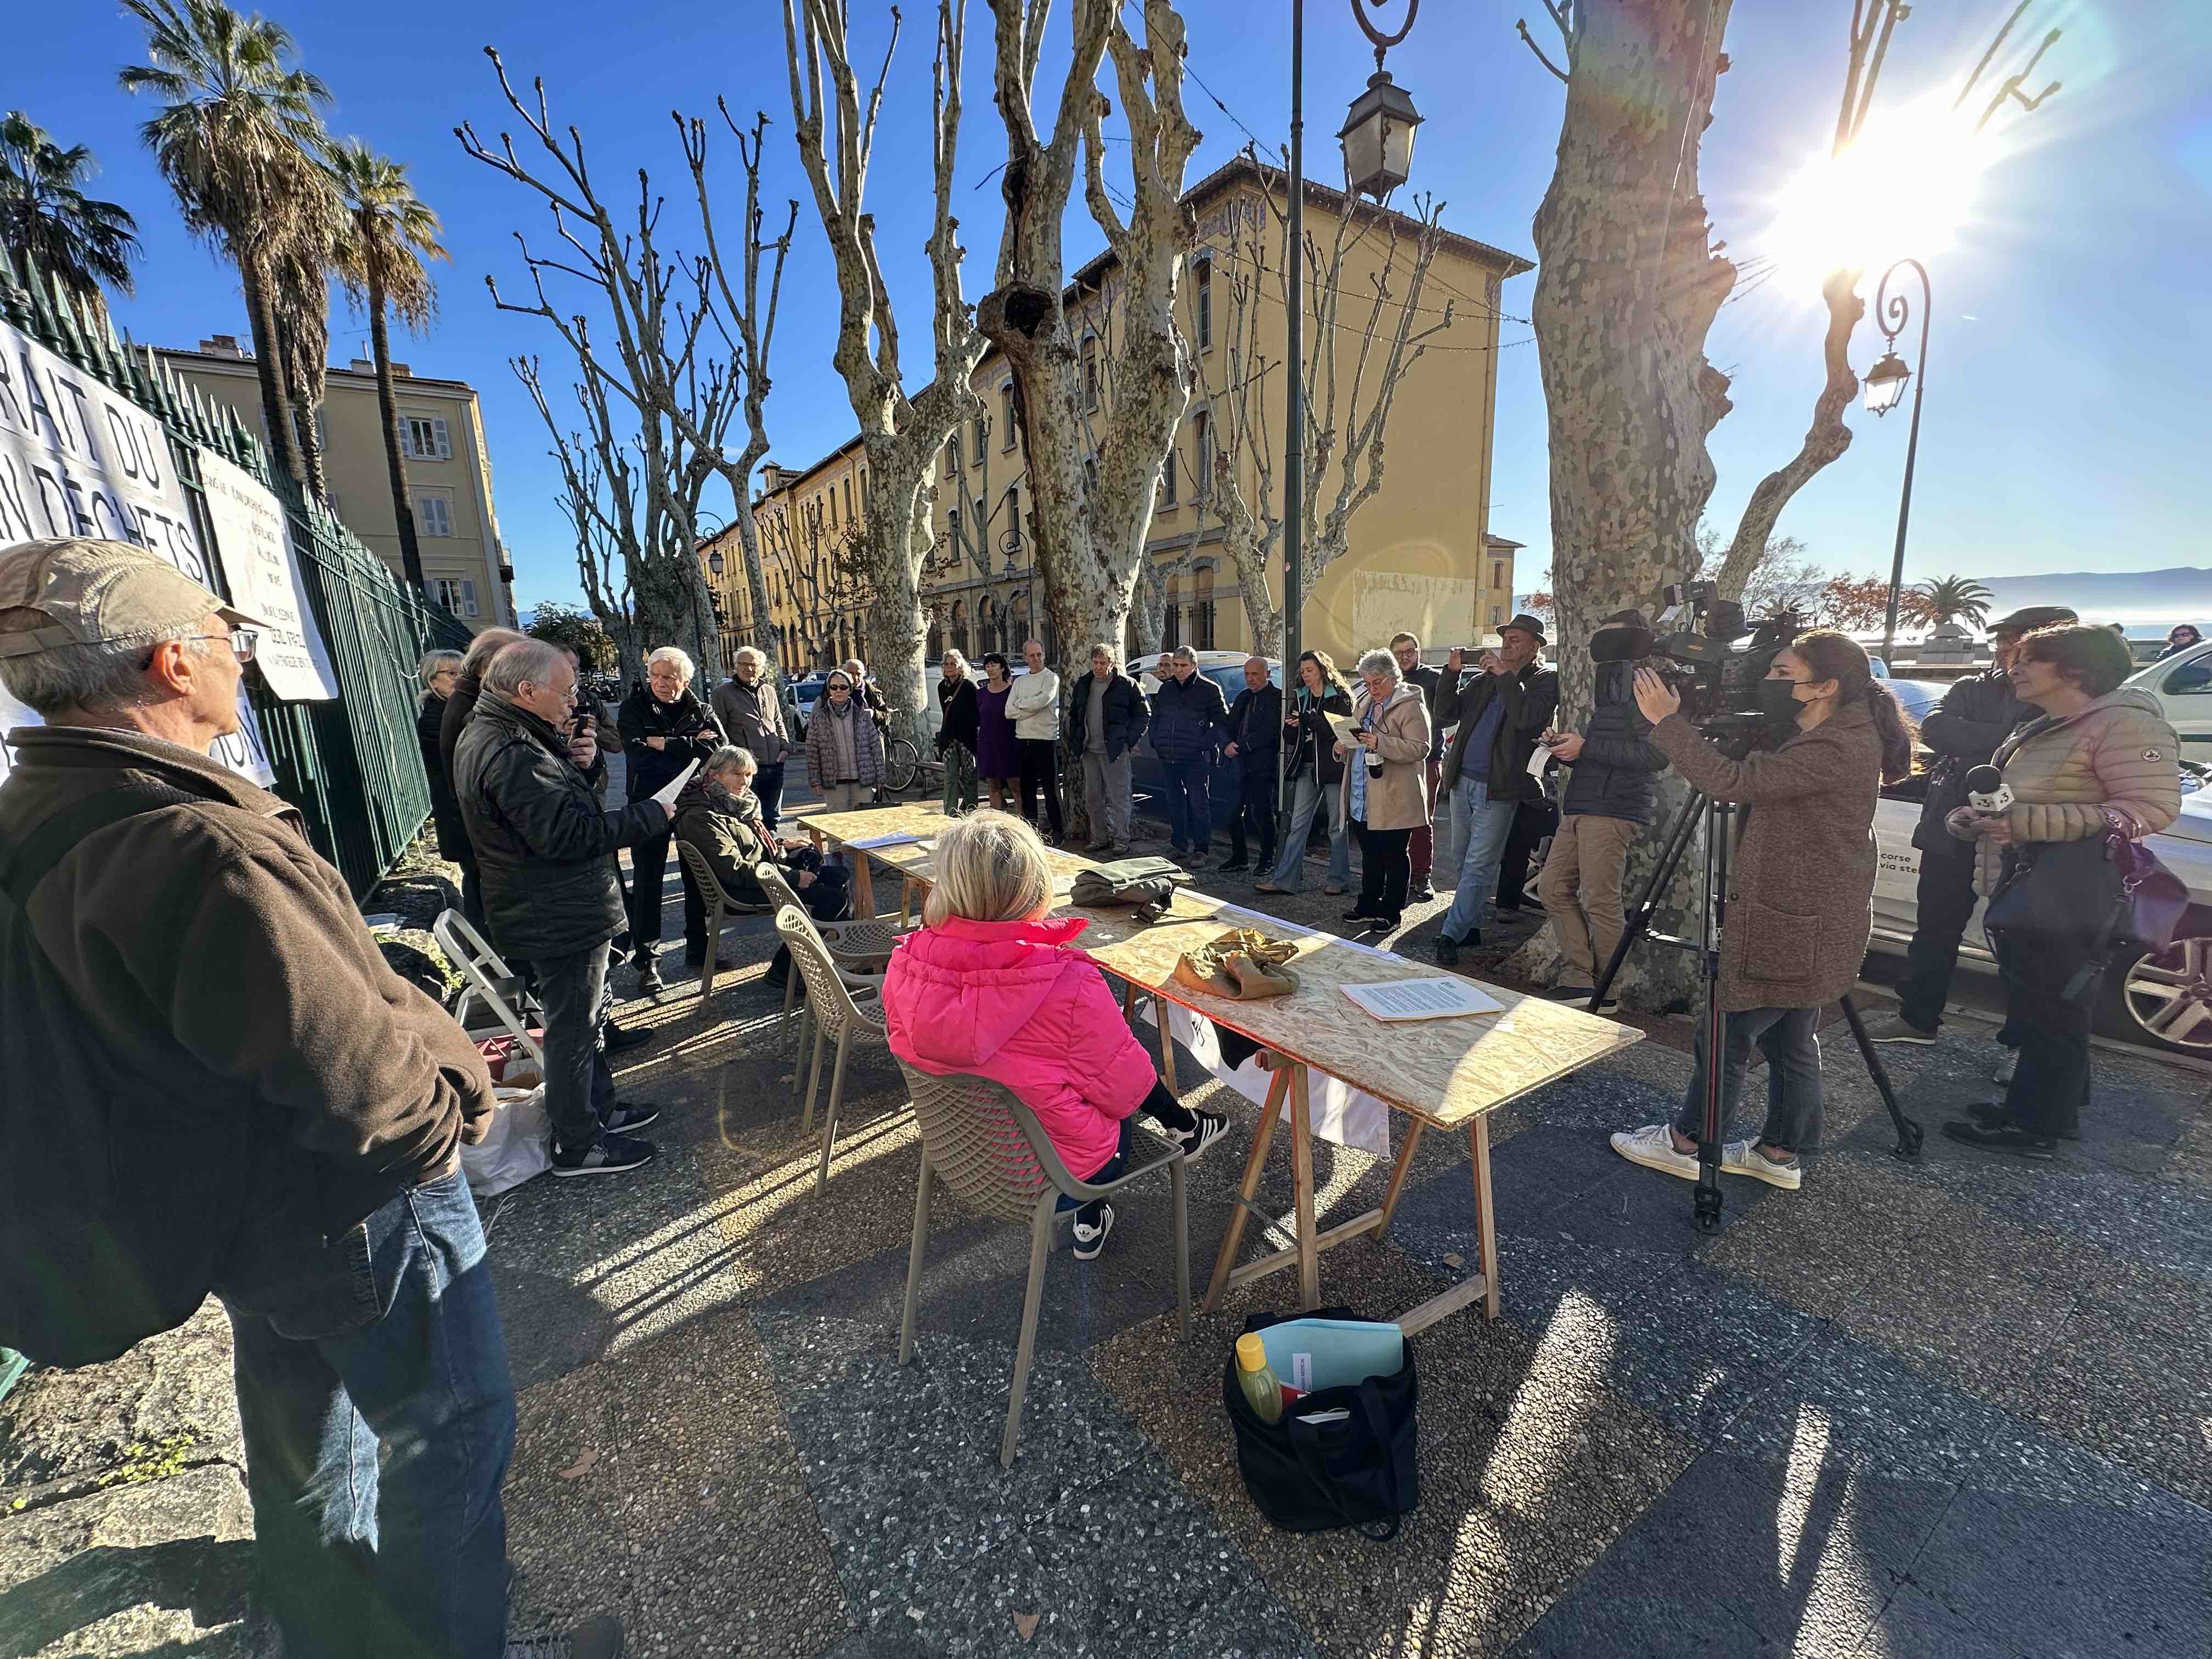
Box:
(223, 1170), (515, 1659)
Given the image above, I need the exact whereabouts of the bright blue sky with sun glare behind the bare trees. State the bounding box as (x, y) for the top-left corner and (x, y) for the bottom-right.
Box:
(0, 0), (2212, 608)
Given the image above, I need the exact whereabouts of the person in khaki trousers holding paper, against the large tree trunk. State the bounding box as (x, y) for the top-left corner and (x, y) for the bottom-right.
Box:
(1537, 611), (1666, 1007)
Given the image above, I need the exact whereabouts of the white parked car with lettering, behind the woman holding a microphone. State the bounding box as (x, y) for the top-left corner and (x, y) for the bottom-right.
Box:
(1874, 765), (2212, 1059)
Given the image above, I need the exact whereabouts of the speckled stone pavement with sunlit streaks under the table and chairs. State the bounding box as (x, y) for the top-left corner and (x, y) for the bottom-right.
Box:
(0, 796), (2212, 1659)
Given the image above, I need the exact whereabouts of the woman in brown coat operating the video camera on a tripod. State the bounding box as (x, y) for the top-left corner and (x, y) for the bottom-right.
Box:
(1612, 628), (1914, 1190)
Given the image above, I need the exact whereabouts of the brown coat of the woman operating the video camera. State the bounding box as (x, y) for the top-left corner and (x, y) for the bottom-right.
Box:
(1652, 703), (1882, 1013)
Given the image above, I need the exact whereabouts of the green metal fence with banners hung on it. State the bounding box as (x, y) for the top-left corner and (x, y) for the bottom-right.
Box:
(0, 259), (469, 898)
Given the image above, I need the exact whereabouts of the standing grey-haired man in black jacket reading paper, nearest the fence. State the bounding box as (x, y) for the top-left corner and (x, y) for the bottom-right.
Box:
(454, 639), (684, 1175)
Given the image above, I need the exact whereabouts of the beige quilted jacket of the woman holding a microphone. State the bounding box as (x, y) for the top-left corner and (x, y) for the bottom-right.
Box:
(1995, 686), (2181, 840)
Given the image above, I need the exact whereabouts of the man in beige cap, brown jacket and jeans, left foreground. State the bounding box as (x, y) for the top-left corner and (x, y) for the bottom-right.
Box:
(0, 540), (622, 1659)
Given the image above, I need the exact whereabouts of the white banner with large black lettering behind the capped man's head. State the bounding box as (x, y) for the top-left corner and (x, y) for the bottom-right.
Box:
(0, 323), (276, 787)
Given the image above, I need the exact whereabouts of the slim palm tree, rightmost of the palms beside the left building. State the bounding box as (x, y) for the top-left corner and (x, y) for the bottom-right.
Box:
(325, 139), (444, 597)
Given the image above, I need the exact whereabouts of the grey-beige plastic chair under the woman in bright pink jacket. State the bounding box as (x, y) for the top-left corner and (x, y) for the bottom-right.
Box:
(898, 1059), (1190, 1469)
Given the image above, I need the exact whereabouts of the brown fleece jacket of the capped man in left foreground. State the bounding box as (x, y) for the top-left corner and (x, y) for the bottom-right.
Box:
(0, 728), (493, 1234)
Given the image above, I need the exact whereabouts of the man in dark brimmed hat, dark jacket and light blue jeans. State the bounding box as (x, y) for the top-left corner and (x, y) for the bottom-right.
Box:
(1431, 613), (1560, 967)
